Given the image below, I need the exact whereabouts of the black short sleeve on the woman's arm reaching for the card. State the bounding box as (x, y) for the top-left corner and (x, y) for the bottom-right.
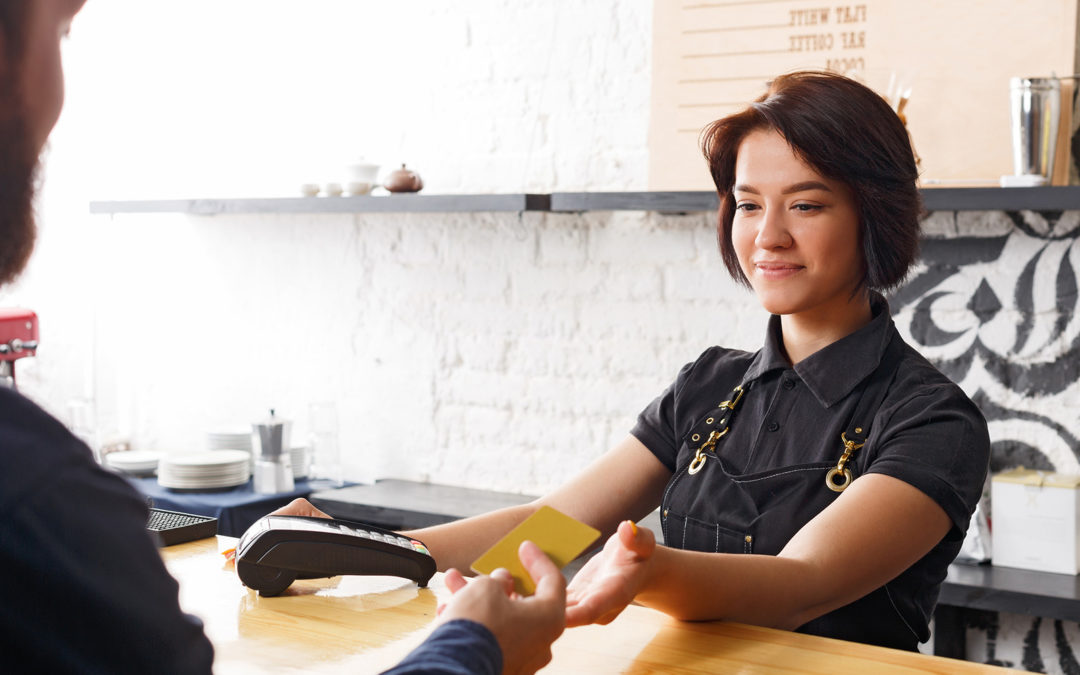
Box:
(866, 383), (990, 538)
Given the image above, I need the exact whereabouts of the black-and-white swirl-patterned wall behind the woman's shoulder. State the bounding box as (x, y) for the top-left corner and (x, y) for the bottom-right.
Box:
(890, 211), (1080, 675)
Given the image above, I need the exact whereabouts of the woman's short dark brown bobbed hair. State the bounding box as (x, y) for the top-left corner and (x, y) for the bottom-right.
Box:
(702, 71), (922, 291)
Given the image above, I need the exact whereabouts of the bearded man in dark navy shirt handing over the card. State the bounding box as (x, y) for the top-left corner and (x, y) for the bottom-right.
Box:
(0, 0), (566, 675)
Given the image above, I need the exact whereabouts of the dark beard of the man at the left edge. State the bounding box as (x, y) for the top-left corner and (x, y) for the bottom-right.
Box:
(0, 100), (38, 285)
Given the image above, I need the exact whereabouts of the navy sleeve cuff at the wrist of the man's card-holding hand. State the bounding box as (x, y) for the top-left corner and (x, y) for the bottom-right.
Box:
(383, 619), (502, 675)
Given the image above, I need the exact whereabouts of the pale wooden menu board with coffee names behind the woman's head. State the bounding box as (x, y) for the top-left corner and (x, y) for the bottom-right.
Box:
(649, 0), (1077, 190)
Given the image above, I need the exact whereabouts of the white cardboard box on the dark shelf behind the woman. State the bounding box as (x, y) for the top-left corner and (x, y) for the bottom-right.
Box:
(990, 467), (1080, 575)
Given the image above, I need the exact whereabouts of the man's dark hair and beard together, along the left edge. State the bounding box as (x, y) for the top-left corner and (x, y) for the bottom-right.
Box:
(0, 0), (38, 285)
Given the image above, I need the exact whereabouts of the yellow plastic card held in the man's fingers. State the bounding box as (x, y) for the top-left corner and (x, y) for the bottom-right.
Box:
(472, 507), (600, 595)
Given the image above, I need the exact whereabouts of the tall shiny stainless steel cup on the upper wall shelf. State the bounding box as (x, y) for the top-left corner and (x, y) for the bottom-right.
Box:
(1009, 78), (1062, 184)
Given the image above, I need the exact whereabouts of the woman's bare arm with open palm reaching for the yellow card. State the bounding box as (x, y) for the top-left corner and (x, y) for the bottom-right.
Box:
(567, 474), (951, 629)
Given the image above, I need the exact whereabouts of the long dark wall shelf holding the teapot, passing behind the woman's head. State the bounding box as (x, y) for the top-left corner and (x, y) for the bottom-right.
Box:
(90, 186), (1080, 216)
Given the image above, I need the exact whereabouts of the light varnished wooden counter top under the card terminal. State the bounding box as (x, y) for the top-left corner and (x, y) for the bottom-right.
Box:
(162, 537), (1009, 675)
